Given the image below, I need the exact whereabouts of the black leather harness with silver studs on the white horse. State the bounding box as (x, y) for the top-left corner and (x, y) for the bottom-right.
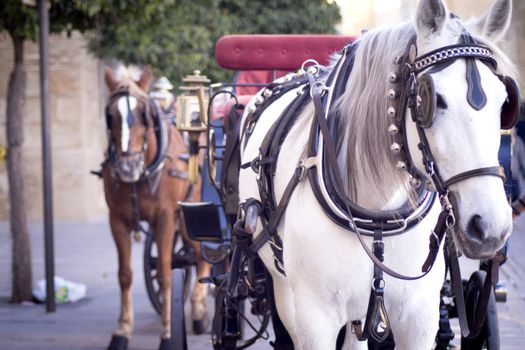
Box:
(234, 31), (519, 342)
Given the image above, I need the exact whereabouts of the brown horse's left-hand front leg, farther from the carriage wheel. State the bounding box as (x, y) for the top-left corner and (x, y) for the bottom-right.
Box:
(109, 215), (133, 339)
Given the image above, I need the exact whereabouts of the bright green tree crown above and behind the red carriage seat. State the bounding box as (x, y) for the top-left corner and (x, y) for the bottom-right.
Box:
(90, 0), (341, 89)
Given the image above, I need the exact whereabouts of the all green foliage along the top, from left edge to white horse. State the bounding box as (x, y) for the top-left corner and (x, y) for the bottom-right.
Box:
(0, 0), (341, 89)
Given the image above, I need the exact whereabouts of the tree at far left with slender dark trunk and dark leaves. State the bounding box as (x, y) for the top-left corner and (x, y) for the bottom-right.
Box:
(0, 0), (170, 302)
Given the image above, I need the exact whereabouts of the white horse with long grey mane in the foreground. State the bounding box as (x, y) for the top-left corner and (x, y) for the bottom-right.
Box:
(239, 0), (515, 350)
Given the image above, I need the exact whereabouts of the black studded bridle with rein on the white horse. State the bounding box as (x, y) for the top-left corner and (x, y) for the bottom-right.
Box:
(303, 36), (519, 280)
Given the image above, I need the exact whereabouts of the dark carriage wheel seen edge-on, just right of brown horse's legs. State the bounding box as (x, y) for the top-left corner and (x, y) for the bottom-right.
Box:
(171, 268), (188, 350)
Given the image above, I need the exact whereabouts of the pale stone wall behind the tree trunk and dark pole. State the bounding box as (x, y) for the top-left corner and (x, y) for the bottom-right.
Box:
(0, 33), (107, 220)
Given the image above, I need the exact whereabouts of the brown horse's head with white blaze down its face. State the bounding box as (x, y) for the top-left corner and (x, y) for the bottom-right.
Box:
(104, 67), (156, 183)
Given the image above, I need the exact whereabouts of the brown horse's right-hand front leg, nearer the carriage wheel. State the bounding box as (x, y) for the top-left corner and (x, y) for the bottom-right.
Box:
(154, 210), (175, 339)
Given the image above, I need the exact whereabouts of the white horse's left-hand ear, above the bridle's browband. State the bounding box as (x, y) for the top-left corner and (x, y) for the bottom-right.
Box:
(416, 0), (448, 37)
